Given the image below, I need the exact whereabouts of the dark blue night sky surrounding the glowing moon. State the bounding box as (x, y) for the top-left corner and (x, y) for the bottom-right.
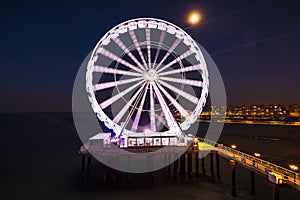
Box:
(0, 0), (300, 112)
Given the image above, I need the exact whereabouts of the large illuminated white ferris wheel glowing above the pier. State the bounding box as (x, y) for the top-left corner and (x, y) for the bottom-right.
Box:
(86, 18), (209, 141)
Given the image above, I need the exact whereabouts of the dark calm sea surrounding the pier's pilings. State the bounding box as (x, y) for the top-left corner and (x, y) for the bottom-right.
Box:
(0, 113), (300, 200)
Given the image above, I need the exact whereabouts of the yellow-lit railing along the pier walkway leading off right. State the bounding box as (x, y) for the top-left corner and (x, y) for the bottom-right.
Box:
(199, 138), (300, 185)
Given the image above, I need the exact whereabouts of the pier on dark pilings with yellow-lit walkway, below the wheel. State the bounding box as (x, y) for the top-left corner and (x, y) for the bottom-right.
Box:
(78, 138), (300, 200)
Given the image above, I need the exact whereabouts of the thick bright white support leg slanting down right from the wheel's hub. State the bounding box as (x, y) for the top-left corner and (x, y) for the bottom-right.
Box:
(151, 82), (182, 137)
